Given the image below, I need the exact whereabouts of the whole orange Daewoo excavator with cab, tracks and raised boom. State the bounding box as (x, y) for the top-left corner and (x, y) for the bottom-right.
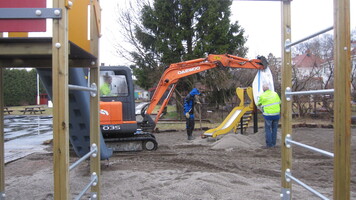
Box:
(99, 54), (267, 151)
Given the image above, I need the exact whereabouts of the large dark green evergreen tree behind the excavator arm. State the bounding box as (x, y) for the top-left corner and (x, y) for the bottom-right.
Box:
(127, 0), (247, 97)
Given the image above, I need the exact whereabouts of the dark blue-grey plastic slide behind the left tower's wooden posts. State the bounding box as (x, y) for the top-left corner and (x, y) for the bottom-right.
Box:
(37, 68), (113, 160)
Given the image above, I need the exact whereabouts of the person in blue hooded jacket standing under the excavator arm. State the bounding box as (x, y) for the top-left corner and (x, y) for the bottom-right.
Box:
(184, 88), (200, 140)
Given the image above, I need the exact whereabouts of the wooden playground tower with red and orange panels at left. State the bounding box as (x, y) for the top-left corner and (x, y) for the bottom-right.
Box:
(0, 0), (102, 199)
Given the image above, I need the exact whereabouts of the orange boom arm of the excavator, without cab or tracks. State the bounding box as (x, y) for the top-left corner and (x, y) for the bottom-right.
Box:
(141, 54), (267, 130)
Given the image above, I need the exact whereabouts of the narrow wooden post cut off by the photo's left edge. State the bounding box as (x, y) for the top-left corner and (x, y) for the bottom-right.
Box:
(0, 33), (5, 199)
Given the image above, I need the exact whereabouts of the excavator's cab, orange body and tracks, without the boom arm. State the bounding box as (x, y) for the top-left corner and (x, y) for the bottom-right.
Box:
(98, 66), (157, 151)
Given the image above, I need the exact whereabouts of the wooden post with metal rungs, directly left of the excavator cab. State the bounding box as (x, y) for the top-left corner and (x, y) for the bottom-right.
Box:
(90, 0), (101, 200)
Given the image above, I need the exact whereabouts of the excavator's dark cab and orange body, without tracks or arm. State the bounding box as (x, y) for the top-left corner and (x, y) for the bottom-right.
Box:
(99, 67), (137, 137)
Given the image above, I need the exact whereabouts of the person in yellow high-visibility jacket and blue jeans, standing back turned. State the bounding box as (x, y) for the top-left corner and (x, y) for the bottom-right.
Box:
(257, 84), (281, 148)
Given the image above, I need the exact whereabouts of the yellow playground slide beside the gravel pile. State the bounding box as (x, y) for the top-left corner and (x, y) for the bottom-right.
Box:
(203, 87), (254, 138)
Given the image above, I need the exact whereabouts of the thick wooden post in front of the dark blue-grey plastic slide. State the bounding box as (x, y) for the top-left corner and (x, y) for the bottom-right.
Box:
(52, 0), (70, 200)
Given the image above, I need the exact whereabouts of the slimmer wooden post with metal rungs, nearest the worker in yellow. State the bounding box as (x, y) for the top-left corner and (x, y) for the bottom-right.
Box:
(281, 1), (292, 199)
